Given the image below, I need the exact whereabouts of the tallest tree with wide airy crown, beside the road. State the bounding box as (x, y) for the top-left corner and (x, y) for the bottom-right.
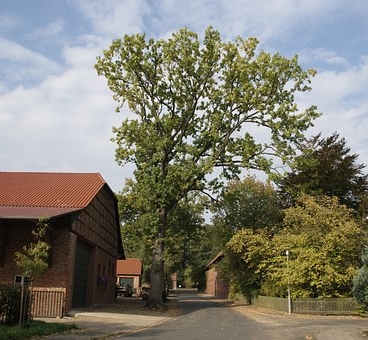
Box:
(95, 28), (318, 307)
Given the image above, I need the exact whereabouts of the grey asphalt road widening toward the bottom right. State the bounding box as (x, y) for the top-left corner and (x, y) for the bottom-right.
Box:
(115, 294), (368, 340)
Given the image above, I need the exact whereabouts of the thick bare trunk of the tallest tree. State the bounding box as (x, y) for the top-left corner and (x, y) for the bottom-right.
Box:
(146, 209), (167, 309)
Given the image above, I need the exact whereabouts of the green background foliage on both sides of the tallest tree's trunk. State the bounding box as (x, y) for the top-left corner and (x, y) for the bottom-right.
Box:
(118, 179), (204, 283)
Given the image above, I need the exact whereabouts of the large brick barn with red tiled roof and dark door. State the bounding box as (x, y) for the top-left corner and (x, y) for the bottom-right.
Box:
(0, 172), (125, 317)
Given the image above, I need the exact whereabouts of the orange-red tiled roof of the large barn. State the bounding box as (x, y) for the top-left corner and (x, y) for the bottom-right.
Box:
(0, 172), (106, 218)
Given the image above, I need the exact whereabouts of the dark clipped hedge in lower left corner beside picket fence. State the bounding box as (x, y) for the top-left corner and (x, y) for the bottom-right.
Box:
(0, 284), (29, 325)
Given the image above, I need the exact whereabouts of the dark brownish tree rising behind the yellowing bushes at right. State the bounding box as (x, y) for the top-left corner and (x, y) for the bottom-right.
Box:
(278, 133), (368, 215)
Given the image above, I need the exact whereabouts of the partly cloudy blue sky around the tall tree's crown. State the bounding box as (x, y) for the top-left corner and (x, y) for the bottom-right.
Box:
(0, 0), (368, 191)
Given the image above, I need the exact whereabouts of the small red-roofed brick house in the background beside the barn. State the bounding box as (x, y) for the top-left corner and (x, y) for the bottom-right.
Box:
(116, 258), (143, 293)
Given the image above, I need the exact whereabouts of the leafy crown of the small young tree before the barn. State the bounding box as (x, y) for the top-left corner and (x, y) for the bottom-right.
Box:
(15, 219), (51, 278)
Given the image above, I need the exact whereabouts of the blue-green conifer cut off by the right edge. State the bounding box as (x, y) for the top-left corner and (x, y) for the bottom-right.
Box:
(353, 246), (368, 311)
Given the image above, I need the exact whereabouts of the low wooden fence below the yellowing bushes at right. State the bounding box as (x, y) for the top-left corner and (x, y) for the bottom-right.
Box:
(252, 296), (359, 315)
